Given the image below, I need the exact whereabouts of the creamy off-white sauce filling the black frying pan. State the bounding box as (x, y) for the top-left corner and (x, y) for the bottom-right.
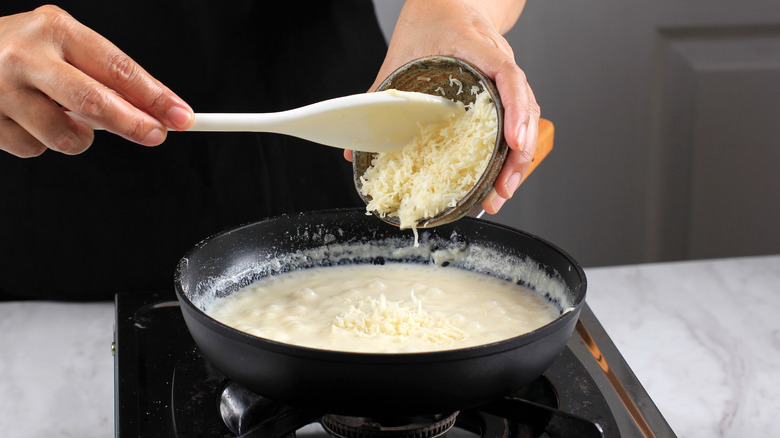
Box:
(207, 263), (560, 353)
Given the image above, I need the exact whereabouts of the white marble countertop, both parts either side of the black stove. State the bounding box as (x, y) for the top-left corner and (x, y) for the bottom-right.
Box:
(0, 255), (780, 438)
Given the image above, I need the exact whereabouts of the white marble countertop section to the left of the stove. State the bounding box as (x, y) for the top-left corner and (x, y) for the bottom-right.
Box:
(0, 302), (114, 438)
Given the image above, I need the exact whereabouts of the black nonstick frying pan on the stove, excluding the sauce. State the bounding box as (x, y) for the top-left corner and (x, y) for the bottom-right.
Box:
(175, 209), (586, 418)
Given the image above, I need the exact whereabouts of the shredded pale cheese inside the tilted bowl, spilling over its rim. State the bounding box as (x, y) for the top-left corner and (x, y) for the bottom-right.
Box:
(360, 88), (498, 236)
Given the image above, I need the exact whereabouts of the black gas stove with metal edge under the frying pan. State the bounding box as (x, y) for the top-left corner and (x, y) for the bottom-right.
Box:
(114, 293), (675, 438)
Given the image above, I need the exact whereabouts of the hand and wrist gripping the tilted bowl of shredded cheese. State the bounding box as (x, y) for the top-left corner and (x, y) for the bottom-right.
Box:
(347, 0), (540, 214)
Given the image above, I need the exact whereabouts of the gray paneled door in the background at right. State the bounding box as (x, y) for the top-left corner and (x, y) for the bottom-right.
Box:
(376, 0), (780, 266)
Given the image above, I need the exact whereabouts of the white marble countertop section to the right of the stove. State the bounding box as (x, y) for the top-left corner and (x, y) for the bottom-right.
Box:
(586, 256), (780, 437)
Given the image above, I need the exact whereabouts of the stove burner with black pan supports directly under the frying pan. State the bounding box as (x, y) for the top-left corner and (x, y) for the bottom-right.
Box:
(219, 378), (604, 438)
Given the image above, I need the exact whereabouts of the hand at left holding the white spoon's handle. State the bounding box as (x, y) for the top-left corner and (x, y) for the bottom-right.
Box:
(0, 6), (193, 157)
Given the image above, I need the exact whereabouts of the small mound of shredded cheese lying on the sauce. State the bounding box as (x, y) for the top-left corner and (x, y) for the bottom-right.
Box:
(333, 293), (469, 345)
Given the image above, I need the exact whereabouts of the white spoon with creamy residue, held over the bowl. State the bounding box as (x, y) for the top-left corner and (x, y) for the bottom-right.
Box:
(69, 90), (465, 152)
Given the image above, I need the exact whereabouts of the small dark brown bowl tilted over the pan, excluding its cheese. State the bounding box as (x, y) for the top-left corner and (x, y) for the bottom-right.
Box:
(352, 56), (509, 228)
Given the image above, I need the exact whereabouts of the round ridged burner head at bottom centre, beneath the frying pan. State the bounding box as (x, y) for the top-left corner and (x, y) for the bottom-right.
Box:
(322, 412), (458, 438)
